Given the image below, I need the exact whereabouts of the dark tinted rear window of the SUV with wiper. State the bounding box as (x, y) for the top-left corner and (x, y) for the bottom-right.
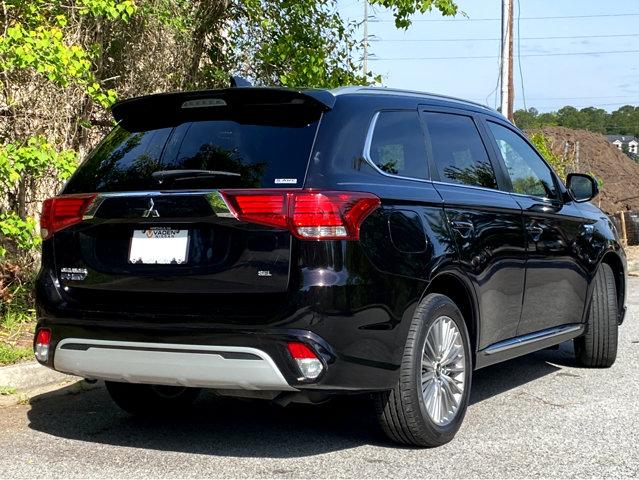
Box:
(64, 117), (319, 193)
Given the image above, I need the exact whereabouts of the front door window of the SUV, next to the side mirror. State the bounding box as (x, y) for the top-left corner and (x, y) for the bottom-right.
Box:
(488, 122), (557, 198)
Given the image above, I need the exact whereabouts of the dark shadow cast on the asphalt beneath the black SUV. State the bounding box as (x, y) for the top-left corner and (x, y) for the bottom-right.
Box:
(28, 345), (572, 458)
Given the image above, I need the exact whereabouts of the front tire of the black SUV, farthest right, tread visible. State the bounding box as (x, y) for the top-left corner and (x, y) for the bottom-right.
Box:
(574, 263), (619, 368)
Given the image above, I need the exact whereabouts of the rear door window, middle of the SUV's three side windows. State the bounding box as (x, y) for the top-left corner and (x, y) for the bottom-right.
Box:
(423, 112), (497, 188)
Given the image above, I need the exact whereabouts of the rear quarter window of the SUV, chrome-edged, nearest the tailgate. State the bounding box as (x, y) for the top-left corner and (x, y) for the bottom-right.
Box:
(369, 111), (428, 179)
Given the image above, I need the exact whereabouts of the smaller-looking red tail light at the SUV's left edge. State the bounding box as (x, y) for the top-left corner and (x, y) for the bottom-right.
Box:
(40, 193), (96, 240)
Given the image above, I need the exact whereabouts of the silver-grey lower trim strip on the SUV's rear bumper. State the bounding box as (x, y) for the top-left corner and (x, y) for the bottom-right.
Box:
(54, 338), (296, 391)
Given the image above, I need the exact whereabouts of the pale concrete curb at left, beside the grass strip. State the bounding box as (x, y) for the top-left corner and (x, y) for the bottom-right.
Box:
(0, 361), (97, 407)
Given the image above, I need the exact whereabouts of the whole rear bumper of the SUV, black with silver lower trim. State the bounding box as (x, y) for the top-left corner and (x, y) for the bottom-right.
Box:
(37, 318), (399, 394)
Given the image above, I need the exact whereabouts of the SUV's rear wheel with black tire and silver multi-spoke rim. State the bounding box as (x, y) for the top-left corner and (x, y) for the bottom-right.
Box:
(375, 294), (472, 447)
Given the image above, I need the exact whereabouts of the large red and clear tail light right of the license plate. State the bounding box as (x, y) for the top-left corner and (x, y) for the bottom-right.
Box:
(220, 190), (381, 240)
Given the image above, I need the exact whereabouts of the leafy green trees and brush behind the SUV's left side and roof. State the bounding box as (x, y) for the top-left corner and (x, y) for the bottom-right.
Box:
(0, 0), (457, 260)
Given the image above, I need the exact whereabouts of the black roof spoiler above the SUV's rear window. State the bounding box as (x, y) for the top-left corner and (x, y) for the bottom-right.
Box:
(111, 85), (335, 126)
